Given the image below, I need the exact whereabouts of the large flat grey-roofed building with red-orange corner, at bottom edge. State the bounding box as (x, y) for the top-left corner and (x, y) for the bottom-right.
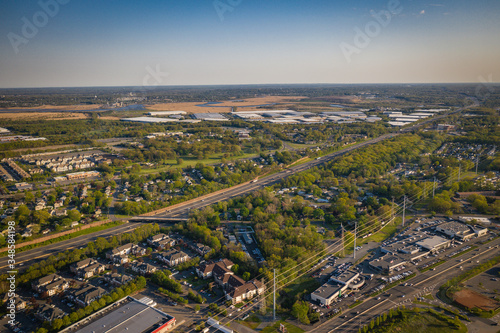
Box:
(76, 297), (175, 333)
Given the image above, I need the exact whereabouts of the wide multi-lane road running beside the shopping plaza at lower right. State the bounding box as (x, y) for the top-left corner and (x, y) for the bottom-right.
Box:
(313, 235), (500, 333)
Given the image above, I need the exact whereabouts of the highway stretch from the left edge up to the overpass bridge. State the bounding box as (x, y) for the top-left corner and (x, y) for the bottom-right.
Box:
(0, 223), (141, 274)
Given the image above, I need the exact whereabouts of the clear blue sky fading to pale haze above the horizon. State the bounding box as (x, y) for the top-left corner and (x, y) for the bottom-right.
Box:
(0, 0), (500, 88)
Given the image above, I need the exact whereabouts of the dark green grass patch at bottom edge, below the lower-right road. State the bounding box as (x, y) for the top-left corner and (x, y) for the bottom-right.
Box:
(369, 311), (467, 333)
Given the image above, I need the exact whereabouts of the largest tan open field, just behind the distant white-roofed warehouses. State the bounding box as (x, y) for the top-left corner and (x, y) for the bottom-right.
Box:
(146, 96), (306, 113)
